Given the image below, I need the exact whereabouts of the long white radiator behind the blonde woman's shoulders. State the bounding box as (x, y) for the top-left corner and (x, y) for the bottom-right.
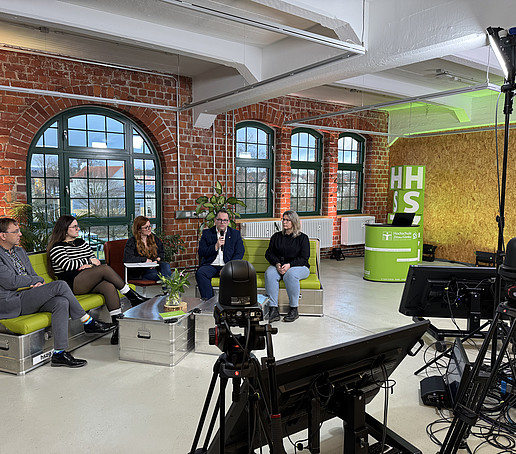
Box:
(240, 219), (333, 248)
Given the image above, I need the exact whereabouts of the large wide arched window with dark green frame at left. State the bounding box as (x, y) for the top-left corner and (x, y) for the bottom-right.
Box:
(27, 107), (161, 244)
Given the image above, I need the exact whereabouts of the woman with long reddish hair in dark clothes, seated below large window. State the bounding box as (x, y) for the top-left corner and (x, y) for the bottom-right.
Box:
(124, 216), (172, 281)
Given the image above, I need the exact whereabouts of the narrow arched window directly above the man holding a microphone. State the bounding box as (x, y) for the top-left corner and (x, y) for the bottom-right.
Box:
(235, 121), (274, 218)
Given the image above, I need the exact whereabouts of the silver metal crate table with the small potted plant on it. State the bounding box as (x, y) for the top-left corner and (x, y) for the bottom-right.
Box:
(119, 296), (200, 366)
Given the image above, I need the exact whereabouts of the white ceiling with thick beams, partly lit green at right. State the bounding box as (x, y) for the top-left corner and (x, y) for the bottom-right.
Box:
(0, 0), (516, 135)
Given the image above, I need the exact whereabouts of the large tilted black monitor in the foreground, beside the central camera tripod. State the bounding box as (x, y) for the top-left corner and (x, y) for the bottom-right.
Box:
(216, 321), (429, 454)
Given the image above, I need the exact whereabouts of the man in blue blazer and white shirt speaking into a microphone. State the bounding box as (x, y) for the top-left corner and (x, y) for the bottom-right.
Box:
(195, 208), (244, 299)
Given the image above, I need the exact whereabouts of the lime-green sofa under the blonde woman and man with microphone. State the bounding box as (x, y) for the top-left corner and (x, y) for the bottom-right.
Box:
(211, 238), (323, 315)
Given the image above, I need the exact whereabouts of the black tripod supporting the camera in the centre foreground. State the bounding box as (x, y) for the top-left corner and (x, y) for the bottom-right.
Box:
(190, 324), (285, 454)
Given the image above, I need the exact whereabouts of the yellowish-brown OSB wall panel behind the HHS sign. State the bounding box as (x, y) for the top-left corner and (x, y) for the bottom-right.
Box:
(389, 128), (516, 263)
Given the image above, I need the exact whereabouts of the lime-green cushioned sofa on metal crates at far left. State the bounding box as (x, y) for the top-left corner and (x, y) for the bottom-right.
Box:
(0, 252), (112, 375)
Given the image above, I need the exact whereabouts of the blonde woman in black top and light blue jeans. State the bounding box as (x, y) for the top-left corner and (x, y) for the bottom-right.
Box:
(265, 210), (310, 322)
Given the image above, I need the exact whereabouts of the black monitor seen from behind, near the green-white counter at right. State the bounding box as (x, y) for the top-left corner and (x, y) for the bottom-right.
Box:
(399, 265), (496, 320)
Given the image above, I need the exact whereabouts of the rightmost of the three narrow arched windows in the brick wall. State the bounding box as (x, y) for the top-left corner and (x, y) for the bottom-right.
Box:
(337, 133), (365, 214)
